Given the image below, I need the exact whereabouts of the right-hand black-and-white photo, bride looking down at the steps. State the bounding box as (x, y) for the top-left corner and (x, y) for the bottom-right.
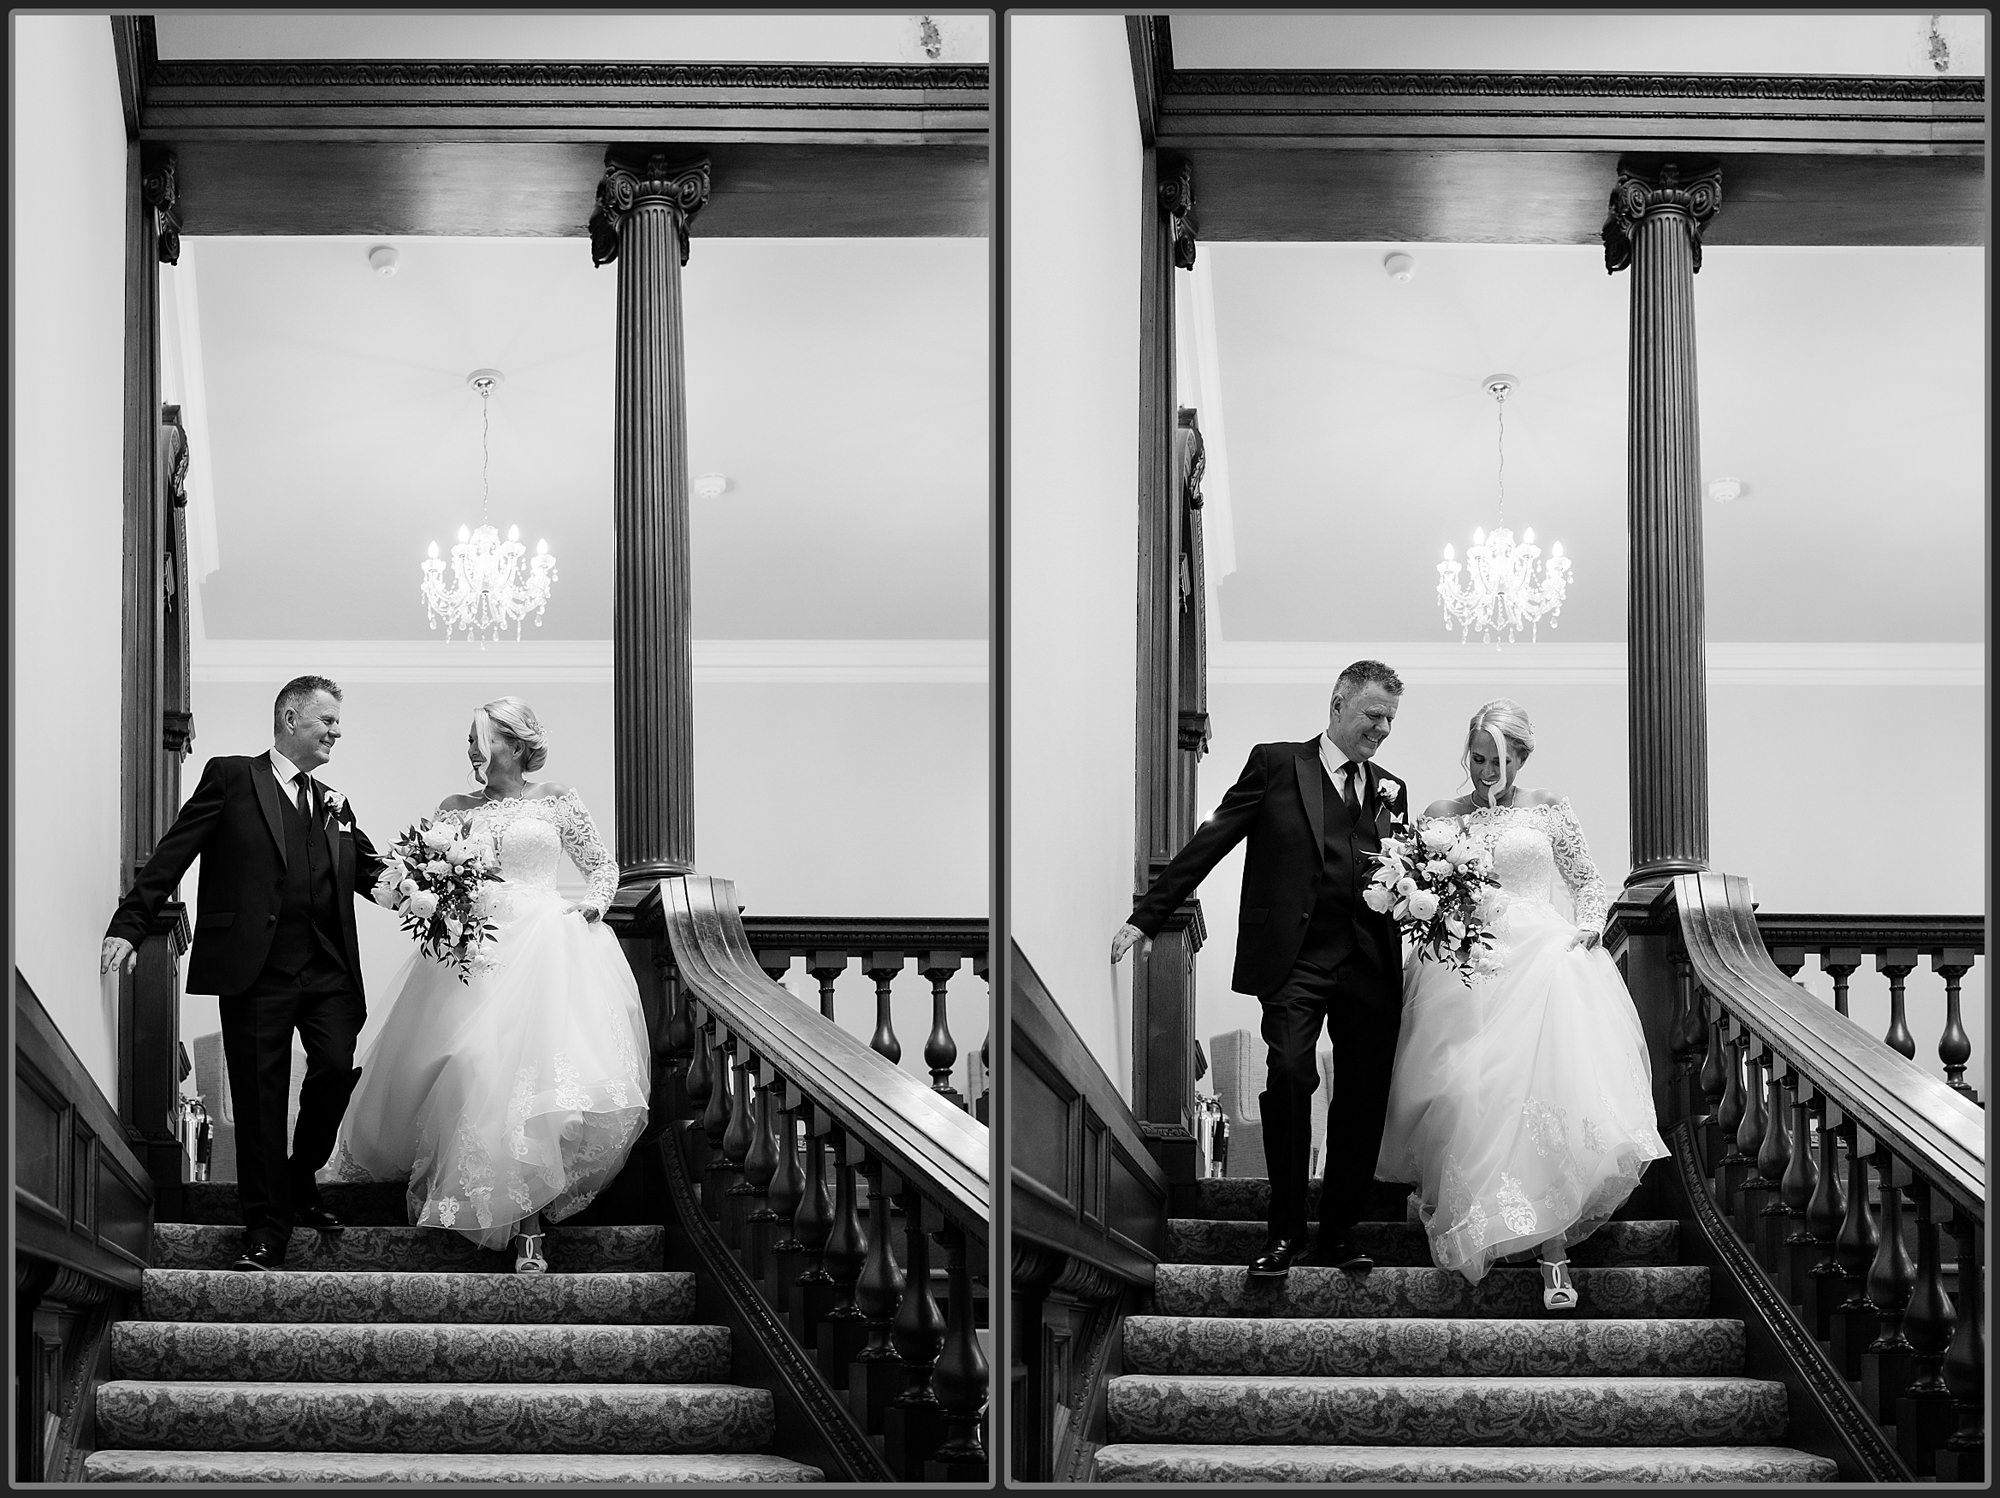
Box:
(1000, 8), (1990, 1492)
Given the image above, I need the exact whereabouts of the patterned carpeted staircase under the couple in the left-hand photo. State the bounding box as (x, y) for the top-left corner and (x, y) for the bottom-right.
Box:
(84, 1184), (822, 1486)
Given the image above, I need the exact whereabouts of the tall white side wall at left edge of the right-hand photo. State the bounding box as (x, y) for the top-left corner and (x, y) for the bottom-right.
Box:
(1006, 16), (1142, 1086)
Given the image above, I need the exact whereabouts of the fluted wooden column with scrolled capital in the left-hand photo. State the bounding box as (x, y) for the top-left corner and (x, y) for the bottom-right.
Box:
(590, 146), (708, 890)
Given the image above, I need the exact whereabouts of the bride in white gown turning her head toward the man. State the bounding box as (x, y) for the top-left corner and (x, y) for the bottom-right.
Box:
(322, 696), (648, 1274)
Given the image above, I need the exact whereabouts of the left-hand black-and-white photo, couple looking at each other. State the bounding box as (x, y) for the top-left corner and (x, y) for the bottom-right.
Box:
(10, 8), (998, 1490)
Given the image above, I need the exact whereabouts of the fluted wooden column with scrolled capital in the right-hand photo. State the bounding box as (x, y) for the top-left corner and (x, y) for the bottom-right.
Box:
(1604, 156), (1722, 884)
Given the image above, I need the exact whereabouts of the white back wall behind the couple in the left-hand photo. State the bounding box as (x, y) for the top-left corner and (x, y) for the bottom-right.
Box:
(182, 676), (990, 1074)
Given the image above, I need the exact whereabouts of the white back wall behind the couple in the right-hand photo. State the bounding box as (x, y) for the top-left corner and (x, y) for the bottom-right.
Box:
(1196, 668), (1988, 1094)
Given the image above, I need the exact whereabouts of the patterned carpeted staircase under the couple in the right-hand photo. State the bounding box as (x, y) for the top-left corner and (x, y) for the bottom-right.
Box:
(1096, 1180), (1836, 1486)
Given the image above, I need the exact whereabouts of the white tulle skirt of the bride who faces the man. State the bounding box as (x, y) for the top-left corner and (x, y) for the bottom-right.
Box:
(320, 884), (650, 1248)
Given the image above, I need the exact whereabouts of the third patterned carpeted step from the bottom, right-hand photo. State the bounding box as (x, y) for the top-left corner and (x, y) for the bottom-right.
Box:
(1124, 1316), (1744, 1378)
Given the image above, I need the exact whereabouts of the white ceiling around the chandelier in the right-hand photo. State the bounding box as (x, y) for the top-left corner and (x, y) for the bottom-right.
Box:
(1176, 241), (1988, 642)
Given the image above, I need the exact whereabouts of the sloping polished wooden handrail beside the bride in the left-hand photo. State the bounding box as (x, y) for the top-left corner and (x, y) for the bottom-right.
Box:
(658, 874), (992, 1242)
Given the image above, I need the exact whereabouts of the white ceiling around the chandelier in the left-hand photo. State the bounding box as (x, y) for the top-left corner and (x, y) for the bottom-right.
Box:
(176, 237), (990, 640)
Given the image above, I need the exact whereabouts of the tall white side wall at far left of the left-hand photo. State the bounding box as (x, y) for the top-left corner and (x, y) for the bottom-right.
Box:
(8, 16), (126, 1098)
